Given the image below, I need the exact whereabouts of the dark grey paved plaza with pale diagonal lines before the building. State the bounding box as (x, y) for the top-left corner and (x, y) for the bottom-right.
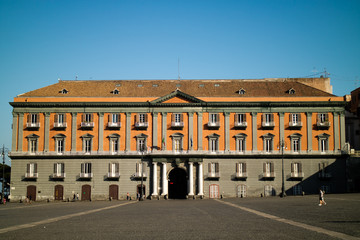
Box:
(0, 194), (360, 240)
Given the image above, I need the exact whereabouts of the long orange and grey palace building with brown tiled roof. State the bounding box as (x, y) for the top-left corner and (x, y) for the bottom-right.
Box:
(10, 78), (348, 201)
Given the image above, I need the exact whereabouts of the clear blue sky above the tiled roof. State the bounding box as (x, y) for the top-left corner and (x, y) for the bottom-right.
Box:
(0, 0), (360, 165)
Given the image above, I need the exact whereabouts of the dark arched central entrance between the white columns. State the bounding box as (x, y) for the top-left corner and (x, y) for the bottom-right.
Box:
(168, 168), (187, 199)
